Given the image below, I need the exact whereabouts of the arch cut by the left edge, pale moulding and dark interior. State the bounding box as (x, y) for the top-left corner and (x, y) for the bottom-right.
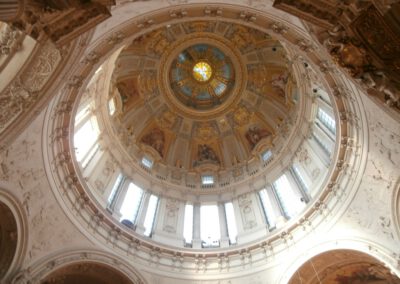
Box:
(0, 185), (28, 283)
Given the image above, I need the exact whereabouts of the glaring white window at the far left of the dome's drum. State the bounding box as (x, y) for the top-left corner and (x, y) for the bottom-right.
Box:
(74, 118), (99, 162)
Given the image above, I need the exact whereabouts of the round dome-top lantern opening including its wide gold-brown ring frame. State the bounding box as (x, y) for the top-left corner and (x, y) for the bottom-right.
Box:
(158, 32), (247, 120)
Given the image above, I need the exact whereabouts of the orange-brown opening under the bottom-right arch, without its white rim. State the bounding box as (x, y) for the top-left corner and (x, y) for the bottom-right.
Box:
(289, 249), (400, 284)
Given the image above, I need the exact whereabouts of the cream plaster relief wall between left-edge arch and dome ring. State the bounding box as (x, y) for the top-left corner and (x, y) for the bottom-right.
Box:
(0, 110), (94, 262)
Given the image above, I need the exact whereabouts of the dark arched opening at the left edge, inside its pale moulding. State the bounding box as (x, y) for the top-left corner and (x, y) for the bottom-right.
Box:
(0, 202), (18, 279)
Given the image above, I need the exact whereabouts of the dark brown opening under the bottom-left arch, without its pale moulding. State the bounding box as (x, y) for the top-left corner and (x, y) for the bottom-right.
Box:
(41, 262), (133, 284)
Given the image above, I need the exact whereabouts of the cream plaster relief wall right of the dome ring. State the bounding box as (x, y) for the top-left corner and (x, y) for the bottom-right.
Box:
(343, 96), (400, 245)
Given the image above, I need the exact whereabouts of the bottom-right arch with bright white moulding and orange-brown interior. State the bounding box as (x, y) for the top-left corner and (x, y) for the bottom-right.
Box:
(278, 239), (400, 284)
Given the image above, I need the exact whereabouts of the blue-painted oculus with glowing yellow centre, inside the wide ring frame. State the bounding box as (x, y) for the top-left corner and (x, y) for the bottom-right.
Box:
(170, 44), (235, 110)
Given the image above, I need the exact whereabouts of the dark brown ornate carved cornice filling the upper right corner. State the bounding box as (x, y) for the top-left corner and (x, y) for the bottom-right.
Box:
(274, 0), (400, 117)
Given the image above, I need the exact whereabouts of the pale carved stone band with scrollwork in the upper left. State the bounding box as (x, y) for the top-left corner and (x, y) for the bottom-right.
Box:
(0, 31), (90, 153)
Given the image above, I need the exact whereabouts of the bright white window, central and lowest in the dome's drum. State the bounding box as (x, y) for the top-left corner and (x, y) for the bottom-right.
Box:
(200, 205), (221, 247)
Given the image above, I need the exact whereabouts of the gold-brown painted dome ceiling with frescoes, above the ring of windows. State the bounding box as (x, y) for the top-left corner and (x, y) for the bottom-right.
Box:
(110, 21), (297, 172)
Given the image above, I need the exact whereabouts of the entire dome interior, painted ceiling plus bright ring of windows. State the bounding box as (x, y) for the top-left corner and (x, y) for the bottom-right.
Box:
(74, 21), (336, 249)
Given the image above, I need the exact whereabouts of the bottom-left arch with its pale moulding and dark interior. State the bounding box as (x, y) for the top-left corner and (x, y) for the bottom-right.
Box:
(11, 249), (146, 284)
